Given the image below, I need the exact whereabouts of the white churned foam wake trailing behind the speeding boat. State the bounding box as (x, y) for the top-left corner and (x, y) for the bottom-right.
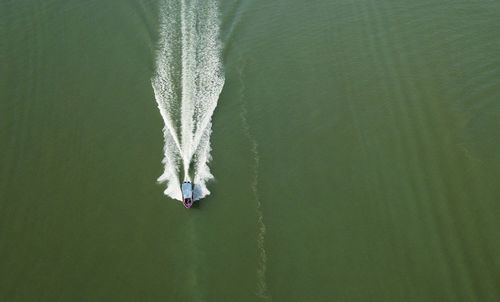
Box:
(151, 0), (224, 200)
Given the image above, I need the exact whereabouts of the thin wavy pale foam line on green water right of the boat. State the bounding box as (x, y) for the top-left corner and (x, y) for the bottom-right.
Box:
(238, 60), (272, 301)
